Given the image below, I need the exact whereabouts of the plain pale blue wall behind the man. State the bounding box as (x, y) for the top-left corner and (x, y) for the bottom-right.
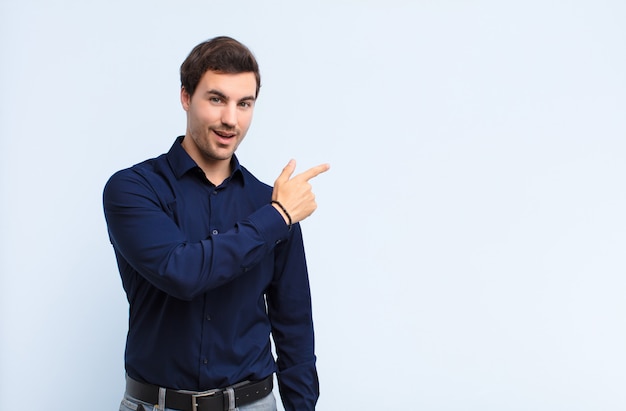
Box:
(0, 0), (626, 411)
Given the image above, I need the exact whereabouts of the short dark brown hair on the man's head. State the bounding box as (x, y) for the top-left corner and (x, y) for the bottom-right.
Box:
(180, 36), (261, 97)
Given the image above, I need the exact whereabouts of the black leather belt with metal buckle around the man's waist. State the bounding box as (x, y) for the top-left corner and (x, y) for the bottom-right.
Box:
(126, 375), (274, 411)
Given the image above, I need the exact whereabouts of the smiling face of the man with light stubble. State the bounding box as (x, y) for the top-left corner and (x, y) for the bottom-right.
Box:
(181, 71), (256, 164)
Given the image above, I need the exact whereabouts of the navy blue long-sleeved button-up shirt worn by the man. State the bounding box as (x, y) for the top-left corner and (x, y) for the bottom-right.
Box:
(104, 137), (319, 411)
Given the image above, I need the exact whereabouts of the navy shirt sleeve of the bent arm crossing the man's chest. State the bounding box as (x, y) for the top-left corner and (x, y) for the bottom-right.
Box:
(103, 169), (289, 300)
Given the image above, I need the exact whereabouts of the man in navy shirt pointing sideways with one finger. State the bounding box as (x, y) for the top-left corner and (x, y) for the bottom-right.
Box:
(104, 37), (329, 411)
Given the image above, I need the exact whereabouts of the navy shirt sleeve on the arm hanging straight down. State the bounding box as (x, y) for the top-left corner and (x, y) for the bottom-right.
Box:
(267, 224), (319, 411)
